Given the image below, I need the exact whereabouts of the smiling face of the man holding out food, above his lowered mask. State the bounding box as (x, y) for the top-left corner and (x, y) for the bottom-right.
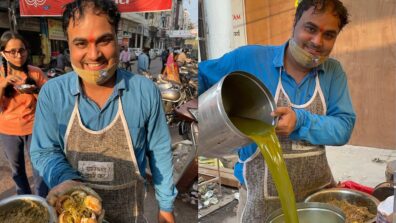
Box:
(67, 8), (119, 70)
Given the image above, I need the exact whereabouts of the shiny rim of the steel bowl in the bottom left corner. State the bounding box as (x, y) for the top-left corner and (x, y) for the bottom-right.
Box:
(0, 195), (57, 223)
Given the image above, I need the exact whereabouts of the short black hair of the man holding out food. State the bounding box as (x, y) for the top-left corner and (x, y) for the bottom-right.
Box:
(63, 0), (121, 37)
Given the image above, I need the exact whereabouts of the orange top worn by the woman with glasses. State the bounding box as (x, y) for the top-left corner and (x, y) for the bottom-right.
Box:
(0, 66), (47, 136)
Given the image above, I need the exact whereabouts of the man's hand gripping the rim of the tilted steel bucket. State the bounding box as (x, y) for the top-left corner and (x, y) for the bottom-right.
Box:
(271, 107), (297, 136)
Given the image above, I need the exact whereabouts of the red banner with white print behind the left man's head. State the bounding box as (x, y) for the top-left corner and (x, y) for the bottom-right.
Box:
(19, 0), (172, 16)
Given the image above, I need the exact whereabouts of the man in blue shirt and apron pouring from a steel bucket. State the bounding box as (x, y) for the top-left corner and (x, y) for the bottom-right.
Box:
(199, 0), (355, 222)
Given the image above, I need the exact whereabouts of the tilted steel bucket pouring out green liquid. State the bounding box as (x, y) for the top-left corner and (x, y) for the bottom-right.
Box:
(198, 71), (275, 157)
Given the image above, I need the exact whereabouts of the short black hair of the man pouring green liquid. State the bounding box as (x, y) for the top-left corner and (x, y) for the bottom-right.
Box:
(294, 0), (349, 30)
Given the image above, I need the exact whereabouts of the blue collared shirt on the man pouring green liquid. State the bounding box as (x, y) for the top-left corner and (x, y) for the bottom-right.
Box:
(198, 43), (356, 184)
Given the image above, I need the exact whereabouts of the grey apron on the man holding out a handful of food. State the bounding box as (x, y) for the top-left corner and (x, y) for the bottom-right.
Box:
(65, 97), (146, 223)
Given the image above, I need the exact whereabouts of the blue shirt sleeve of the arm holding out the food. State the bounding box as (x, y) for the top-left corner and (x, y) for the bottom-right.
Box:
(30, 85), (81, 188)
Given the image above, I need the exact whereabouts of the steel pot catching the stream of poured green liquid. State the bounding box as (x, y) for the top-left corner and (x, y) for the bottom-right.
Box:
(265, 202), (345, 223)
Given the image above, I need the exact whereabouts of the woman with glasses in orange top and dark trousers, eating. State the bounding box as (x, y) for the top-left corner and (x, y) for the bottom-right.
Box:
(0, 31), (48, 197)
